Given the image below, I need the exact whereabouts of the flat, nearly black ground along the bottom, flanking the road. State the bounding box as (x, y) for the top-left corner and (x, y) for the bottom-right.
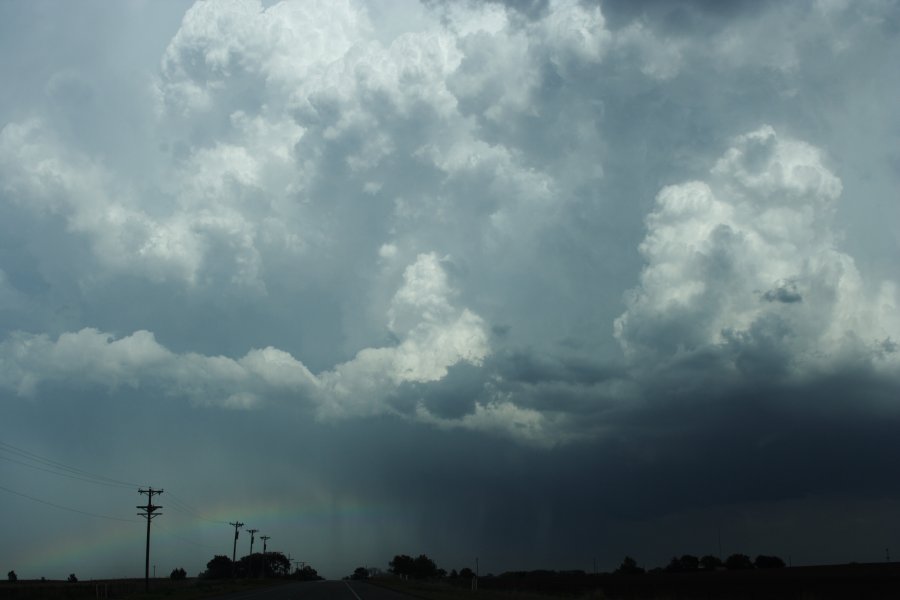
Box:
(0, 563), (900, 600)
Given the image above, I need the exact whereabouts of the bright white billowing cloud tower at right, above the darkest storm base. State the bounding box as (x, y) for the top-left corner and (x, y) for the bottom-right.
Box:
(615, 126), (900, 375)
